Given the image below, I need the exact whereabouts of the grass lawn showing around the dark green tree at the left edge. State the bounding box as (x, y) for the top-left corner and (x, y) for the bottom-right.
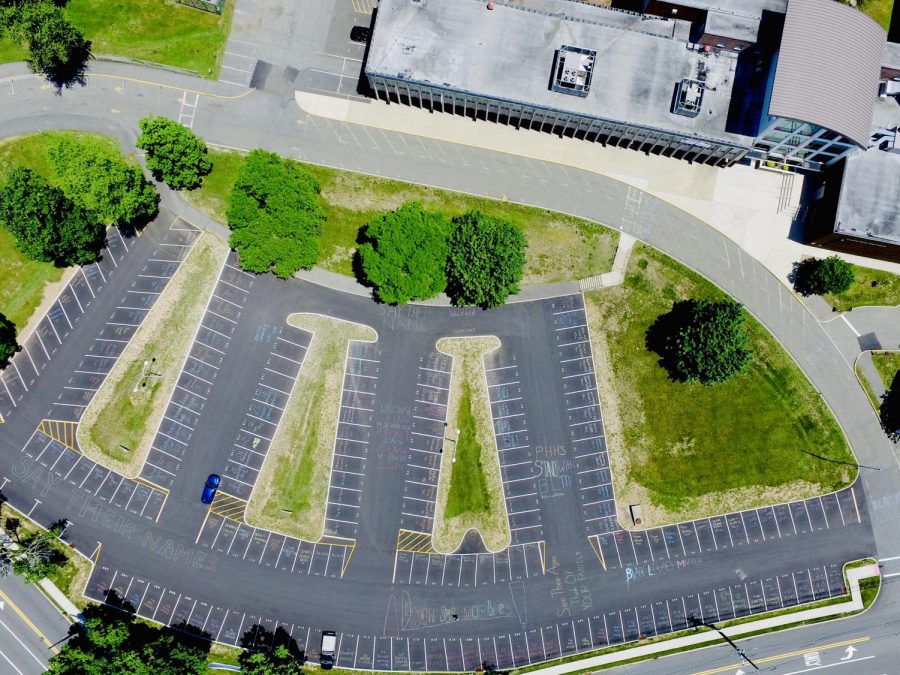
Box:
(0, 131), (123, 331)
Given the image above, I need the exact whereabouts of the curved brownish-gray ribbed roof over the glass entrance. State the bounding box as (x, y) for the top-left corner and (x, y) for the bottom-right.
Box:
(769, 0), (885, 147)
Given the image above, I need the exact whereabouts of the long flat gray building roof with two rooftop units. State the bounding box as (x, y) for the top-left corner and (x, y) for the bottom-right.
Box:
(366, 0), (753, 147)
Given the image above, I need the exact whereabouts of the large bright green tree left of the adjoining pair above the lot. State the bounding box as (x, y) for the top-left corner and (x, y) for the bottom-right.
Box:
(227, 150), (325, 279)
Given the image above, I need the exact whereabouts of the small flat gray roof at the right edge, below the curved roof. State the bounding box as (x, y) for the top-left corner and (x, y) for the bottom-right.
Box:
(834, 148), (900, 244)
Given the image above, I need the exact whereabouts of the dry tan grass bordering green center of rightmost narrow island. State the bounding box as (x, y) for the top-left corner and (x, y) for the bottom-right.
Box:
(432, 336), (511, 553)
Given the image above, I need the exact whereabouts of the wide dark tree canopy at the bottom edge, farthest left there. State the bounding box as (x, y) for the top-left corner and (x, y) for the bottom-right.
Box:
(47, 605), (209, 675)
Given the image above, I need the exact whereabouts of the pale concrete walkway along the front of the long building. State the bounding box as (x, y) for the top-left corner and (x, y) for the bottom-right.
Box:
(295, 91), (900, 287)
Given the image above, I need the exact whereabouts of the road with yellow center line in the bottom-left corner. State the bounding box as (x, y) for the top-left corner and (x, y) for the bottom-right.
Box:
(0, 576), (71, 675)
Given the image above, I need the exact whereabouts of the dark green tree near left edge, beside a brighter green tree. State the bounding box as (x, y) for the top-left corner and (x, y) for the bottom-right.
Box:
(0, 167), (105, 266)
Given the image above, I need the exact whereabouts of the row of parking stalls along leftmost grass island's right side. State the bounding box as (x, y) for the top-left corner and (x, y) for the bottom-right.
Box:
(141, 251), (253, 488)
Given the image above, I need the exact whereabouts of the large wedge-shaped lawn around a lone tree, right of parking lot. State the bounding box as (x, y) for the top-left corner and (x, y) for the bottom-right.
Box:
(586, 244), (856, 527)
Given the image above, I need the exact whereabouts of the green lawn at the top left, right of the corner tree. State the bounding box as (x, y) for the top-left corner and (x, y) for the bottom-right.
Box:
(66, 0), (235, 79)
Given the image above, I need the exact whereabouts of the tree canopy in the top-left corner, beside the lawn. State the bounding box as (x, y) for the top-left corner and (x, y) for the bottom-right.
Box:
(0, 0), (91, 85)
